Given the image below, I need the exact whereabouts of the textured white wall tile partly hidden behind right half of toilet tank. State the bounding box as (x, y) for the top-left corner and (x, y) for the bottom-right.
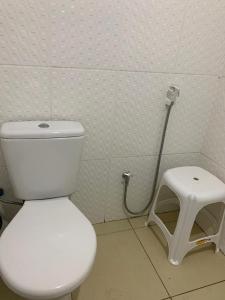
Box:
(52, 68), (116, 159)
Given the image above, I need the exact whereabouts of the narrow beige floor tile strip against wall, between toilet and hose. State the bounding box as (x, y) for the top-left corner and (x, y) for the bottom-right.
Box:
(94, 219), (132, 235)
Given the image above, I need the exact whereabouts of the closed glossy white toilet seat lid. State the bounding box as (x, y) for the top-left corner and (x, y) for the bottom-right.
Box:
(0, 197), (96, 299)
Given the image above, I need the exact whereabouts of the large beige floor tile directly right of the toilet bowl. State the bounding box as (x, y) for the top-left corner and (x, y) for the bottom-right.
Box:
(78, 231), (168, 300)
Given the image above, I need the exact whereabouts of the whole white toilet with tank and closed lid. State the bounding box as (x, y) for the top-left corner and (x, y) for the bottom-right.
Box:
(0, 121), (96, 300)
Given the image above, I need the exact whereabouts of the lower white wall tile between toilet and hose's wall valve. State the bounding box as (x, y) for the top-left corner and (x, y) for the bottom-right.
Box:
(72, 160), (109, 223)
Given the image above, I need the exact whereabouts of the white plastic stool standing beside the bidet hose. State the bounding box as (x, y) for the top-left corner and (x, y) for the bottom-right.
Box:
(146, 167), (225, 265)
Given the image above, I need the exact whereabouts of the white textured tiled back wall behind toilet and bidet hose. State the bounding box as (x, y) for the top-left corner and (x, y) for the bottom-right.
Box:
(0, 0), (225, 222)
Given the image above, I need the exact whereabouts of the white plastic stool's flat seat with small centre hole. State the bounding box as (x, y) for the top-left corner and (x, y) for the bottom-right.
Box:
(164, 166), (225, 203)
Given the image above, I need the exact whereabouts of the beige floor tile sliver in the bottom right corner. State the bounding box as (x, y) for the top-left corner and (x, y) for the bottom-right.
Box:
(172, 282), (225, 300)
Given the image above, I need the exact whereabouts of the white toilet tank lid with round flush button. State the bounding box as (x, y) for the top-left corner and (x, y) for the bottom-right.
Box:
(0, 121), (84, 139)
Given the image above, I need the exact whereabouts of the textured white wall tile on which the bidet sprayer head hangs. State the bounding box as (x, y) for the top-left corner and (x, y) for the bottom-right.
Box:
(112, 72), (218, 157)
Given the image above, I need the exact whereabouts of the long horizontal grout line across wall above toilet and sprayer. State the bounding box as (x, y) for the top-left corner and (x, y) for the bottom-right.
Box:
(0, 64), (221, 78)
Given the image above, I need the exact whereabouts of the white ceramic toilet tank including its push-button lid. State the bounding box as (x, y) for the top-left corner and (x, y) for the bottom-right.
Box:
(0, 121), (84, 200)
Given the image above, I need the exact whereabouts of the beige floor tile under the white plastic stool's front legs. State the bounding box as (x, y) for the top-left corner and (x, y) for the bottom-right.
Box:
(136, 226), (225, 295)
